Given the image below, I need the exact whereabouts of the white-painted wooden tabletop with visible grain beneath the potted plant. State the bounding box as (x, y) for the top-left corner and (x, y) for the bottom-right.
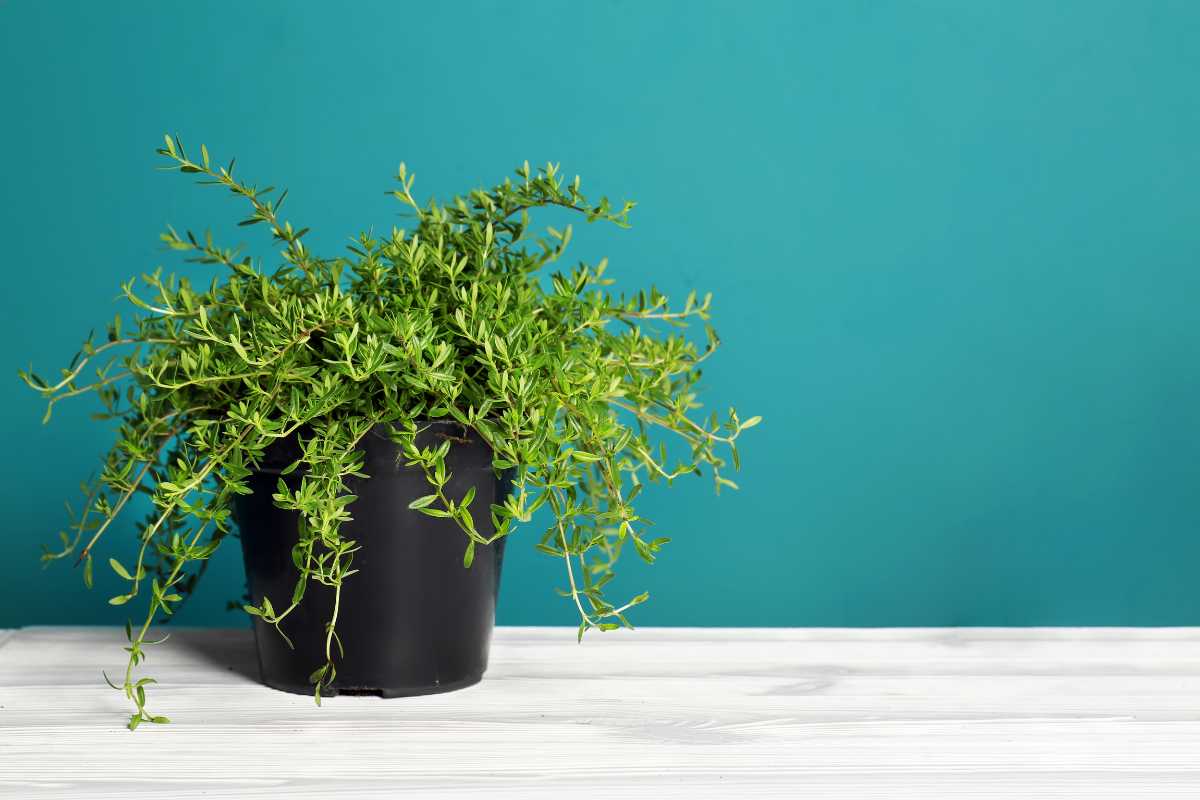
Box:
(0, 627), (1200, 800)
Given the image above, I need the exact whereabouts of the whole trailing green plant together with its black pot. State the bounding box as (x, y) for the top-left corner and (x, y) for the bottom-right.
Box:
(20, 136), (760, 728)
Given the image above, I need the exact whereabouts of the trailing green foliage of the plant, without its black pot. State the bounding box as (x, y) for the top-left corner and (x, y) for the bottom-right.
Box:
(20, 136), (760, 729)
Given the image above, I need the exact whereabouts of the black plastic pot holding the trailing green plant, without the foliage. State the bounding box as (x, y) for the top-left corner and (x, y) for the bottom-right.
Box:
(234, 422), (510, 697)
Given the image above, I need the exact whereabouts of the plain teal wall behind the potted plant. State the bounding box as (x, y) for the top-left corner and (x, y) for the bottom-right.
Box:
(0, 0), (1200, 626)
